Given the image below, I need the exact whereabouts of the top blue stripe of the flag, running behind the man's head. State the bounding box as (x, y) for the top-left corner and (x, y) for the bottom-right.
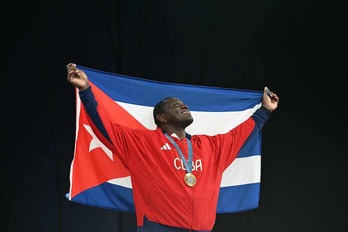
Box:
(79, 67), (262, 112)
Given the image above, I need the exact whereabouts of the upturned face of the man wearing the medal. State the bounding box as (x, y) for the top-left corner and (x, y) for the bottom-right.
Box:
(164, 98), (193, 128)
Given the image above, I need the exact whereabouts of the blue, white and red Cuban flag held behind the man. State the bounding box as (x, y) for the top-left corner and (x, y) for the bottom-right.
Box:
(66, 66), (262, 213)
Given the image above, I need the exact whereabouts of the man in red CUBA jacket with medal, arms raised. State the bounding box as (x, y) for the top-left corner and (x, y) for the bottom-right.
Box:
(67, 63), (279, 232)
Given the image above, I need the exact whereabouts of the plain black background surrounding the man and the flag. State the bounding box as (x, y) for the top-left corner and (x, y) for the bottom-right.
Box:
(0, 0), (348, 232)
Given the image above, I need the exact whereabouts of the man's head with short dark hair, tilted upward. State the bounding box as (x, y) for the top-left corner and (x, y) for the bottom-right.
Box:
(153, 97), (193, 129)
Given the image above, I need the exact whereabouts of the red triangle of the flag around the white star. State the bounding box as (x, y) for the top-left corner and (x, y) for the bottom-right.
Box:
(70, 82), (145, 198)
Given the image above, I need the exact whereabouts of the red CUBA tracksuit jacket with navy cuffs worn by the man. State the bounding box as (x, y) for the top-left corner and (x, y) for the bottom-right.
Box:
(80, 88), (269, 230)
